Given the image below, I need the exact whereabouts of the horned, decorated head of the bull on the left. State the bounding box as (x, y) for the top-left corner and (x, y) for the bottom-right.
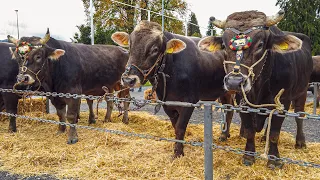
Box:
(8, 29), (65, 88)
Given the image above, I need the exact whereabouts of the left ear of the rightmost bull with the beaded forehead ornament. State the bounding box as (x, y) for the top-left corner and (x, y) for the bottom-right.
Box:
(198, 36), (222, 52)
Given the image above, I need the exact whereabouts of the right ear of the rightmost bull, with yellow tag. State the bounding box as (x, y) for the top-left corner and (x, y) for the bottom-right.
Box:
(272, 35), (302, 53)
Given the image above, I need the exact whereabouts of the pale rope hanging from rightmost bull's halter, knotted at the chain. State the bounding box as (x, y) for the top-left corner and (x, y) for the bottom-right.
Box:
(241, 84), (284, 159)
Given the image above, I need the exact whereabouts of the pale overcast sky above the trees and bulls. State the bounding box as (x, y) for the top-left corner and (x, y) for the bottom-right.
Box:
(0, 0), (279, 41)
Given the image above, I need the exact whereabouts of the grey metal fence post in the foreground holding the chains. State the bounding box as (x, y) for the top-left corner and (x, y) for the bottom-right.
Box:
(204, 104), (213, 180)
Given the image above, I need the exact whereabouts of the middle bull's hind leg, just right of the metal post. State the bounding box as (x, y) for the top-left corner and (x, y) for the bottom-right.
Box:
(219, 93), (234, 141)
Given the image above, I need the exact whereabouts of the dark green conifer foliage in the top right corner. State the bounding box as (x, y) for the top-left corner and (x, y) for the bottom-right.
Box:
(276, 0), (320, 55)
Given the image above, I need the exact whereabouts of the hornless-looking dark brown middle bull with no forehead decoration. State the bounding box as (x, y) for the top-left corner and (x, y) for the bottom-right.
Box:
(112, 21), (232, 157)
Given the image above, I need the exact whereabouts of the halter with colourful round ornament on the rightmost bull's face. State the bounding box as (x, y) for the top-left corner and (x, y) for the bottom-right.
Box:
(223, 26), (268, 81)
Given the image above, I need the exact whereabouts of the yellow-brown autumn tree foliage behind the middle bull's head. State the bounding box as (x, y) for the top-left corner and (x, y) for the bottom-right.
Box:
(83, 0), (187, 34)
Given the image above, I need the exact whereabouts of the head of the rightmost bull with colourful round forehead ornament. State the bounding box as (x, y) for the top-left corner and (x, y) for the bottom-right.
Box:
(198, 11), (302, 92)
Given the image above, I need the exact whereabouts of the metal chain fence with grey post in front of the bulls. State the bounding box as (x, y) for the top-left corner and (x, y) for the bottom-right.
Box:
(0, 86), (320, 179)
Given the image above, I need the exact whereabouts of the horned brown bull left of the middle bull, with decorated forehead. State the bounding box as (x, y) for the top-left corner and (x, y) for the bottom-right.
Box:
(8, 29), (129, 144)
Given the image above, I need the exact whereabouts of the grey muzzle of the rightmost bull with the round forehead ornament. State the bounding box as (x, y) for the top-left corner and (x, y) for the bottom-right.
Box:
(224, 74), (247, 92)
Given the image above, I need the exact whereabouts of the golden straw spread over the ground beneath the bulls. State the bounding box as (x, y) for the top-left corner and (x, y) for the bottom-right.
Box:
(0, 110), (320, 179)
